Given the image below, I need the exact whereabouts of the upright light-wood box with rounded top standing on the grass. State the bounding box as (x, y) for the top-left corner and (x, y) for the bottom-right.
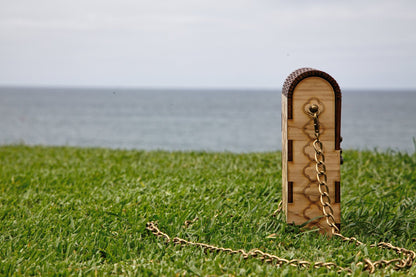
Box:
(282, 68), (341, 233)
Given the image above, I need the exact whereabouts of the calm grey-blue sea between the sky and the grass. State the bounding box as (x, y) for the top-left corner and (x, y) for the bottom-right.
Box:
(0, 87), (416, 153)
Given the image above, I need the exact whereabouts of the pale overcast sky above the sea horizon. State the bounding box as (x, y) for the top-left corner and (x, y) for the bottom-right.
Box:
(0, 0), (416, 89)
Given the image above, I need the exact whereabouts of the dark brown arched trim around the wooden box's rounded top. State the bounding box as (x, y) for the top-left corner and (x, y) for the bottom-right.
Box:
(282, 67), (342, 150)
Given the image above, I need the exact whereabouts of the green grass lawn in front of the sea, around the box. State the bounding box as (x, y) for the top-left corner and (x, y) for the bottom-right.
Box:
(0, 145), (416, 276)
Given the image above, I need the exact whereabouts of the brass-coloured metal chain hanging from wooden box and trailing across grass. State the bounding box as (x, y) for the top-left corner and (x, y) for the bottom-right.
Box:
(146, 105), (416, 273)
